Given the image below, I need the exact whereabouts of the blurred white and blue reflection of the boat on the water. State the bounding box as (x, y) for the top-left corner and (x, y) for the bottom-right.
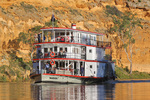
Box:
(32, 84), (115, 100)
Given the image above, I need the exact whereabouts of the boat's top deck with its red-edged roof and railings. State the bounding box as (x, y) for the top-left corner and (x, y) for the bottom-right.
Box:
(34, 27), (111, 48)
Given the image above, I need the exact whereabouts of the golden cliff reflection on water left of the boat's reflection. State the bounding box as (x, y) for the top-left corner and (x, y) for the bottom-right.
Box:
(0, 83), (31, 100)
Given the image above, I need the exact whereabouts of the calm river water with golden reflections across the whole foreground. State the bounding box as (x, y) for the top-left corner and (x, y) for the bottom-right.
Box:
(0, 80), (150, 100)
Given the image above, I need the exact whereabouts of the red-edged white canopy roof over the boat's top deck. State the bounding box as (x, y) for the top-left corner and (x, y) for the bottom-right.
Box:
(41, 27), (104, 36)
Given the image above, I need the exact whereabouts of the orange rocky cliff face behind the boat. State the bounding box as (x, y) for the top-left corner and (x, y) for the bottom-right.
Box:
(0, 0), (150, 72)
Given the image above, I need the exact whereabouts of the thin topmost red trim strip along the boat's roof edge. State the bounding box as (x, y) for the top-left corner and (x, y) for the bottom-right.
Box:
(41, 27), (104, 35)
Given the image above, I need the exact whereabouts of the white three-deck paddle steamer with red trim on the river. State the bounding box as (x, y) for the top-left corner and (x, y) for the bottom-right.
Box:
(30, 24), (115, 84)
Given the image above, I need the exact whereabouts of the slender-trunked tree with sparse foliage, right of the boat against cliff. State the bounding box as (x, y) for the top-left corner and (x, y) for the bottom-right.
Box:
(106, 6), (142, 74)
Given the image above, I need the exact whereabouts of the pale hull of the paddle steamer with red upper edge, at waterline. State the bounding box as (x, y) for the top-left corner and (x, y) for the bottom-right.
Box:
(30, 74), (113, 84)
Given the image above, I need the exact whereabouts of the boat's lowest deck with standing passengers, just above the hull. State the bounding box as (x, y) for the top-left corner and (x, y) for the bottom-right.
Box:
(32, 59), (115, 77)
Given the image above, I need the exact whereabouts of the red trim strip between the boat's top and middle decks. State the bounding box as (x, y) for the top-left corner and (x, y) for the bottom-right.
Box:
(33, 42), (111, 49)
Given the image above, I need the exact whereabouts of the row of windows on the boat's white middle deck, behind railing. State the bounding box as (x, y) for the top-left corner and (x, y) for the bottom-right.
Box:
(37, 46), (85, 59)
